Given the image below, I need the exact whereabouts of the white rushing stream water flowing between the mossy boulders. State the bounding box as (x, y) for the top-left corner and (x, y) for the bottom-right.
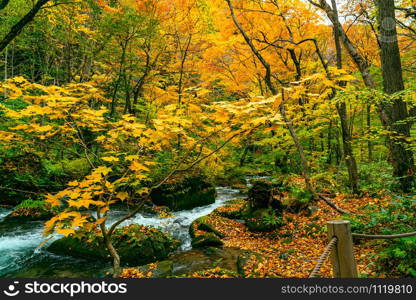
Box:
(0, 187), (242, 278)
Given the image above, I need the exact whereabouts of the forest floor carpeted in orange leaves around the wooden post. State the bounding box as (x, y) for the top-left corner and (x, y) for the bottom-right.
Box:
(202, 185), (390, 278)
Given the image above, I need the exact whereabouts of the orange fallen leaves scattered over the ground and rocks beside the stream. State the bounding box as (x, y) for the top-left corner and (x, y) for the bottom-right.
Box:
(121, 178), (388, 278)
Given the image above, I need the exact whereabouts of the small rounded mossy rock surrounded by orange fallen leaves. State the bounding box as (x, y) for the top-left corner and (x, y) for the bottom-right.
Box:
(244, 208), (283, 232)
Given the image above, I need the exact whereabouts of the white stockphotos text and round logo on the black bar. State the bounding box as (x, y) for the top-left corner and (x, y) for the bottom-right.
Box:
(3, 280), (127, 297)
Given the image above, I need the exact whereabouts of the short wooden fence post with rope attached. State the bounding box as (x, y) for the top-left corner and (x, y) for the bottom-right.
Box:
(327, 220), (358, 278)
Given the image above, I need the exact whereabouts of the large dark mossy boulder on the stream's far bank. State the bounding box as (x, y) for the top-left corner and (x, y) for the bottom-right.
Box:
(150, 176), (216, 211)
